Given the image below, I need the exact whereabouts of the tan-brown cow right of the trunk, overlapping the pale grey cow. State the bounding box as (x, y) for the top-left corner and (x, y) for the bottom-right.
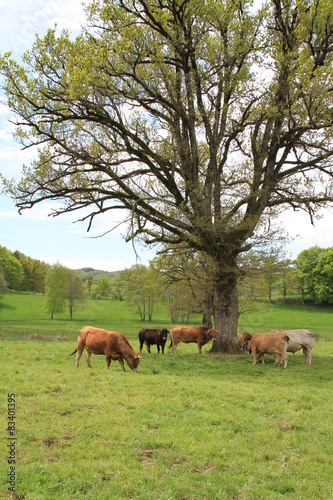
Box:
(247, 333), (289, 368)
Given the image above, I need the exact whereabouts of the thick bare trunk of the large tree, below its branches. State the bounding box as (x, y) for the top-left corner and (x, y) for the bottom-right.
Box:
(211, 264), (239, 353)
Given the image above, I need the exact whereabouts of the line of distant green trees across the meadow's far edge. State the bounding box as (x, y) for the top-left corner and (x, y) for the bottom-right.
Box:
(0, 246), (333, 326)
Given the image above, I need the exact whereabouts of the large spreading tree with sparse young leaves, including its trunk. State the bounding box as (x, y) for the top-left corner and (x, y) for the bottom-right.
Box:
(0, 0), (333, 351)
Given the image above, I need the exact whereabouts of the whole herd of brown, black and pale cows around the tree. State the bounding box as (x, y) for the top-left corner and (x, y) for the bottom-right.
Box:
(71, 326), (315, 371)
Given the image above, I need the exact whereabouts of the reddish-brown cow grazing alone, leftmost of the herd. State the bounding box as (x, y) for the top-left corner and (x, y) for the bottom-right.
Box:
(70, 326), (141, 372)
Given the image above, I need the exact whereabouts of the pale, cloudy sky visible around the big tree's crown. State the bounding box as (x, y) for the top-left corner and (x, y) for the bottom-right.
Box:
(0, 0), (333, 271)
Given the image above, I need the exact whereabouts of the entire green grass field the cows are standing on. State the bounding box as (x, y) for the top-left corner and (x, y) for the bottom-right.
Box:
(0, 294), (333, 500)
